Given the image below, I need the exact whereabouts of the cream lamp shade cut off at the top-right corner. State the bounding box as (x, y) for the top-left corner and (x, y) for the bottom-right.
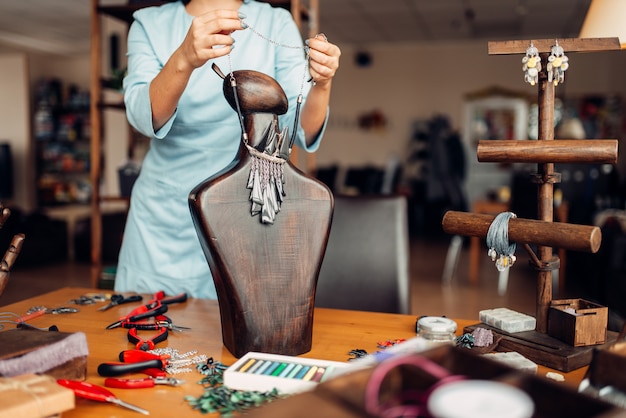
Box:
(579, 0), (626, 49)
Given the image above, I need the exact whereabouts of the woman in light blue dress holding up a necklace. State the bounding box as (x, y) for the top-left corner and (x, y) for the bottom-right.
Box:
(115, 0), (341, 299)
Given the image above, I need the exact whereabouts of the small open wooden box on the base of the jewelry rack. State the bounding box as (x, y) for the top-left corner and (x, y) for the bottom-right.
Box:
(548, 299), (609, 347)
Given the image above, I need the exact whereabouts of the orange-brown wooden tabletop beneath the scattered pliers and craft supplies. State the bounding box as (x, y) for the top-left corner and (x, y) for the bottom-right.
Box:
(0, 288), (586, 418)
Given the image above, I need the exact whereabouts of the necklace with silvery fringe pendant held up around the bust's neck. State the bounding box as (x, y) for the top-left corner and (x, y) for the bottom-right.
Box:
(222, 19), (311, 224)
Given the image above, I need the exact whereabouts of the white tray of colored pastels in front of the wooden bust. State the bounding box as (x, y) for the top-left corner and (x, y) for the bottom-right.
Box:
(224, 352), (347, 393)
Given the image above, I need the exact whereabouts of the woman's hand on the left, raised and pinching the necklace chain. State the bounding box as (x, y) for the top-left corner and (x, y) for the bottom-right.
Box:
(179, 10), (243, 69)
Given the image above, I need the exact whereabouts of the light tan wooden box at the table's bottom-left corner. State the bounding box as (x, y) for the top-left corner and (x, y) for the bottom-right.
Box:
(0, 374), (75, 418)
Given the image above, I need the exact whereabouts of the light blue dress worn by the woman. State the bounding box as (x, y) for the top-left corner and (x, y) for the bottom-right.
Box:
(115, 1), (323, 299)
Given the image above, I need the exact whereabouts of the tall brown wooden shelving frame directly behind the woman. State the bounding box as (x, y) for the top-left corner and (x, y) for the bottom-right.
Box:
(90, 0), (319, 287)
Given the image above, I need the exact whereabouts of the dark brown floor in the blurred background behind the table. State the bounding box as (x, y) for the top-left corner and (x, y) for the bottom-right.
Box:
(0, 239), (544, 319)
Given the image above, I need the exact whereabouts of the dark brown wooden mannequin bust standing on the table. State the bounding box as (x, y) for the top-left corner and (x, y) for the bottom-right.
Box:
(189, 65), (333, 357)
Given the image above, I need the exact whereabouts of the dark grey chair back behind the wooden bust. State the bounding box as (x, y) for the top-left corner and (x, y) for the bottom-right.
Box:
(315, 195), (411, 314)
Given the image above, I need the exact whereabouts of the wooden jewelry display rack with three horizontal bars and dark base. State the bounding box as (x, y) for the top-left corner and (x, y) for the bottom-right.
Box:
(442, 38), (620, 372)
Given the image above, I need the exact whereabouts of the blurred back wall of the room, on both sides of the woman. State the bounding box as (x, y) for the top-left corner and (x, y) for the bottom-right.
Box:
(0, 38), (626, 212)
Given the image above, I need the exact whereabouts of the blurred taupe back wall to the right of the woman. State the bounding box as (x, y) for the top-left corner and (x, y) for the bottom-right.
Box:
(316, 40), (626, 172)
